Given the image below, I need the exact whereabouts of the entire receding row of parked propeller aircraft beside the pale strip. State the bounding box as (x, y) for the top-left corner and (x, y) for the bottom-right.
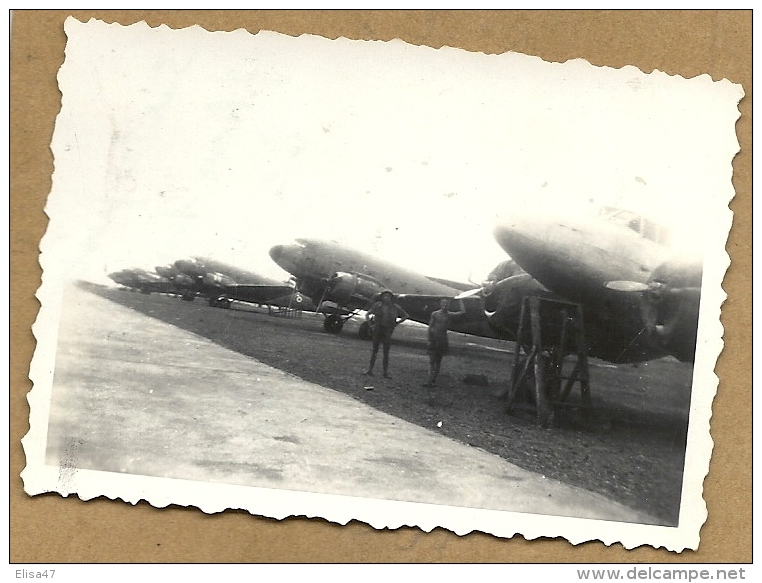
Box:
(107, 208), (702, 363)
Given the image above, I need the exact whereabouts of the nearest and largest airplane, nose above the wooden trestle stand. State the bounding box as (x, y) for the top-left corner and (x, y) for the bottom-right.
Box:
(486, 207), (703, 363)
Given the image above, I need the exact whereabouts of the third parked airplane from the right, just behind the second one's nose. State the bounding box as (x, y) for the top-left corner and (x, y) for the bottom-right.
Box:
(171, 257), (314, 310)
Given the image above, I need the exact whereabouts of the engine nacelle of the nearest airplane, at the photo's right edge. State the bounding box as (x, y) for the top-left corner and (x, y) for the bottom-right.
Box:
(641, 259), (703, 362)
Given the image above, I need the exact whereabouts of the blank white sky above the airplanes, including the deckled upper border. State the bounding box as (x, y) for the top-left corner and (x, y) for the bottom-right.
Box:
(42, 18), (741, 282)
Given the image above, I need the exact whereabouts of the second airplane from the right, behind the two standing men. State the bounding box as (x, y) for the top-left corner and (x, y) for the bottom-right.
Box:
(270, 238), (524, 339)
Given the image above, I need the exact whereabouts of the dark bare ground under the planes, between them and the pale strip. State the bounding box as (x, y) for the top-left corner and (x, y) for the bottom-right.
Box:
(83, 284), (693, 525)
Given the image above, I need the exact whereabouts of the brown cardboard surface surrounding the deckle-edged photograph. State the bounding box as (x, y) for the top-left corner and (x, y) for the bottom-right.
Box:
(9, 10), (752, 563)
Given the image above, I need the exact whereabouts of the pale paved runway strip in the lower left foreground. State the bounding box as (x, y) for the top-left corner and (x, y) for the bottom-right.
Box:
(47, 287), (654, 523)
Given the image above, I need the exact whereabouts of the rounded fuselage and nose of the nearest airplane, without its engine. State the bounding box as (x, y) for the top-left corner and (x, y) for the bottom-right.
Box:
(495, 215), (700, 362)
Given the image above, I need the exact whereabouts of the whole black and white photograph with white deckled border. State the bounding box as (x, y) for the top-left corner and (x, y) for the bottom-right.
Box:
(22, 18), (743, 552)
